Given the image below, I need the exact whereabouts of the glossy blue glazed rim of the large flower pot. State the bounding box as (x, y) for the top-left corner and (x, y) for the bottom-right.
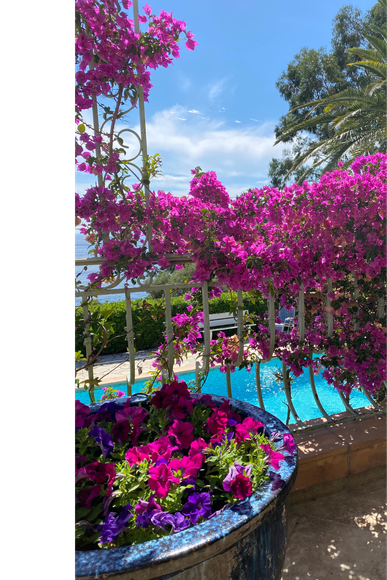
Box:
(74, 394), (298, 578)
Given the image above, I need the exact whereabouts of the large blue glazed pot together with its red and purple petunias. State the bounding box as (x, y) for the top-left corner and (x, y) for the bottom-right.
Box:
(74, 381), (297, 579)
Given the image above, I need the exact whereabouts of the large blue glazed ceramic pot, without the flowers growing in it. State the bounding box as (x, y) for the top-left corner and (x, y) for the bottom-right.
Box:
(74, 395), (298, 580)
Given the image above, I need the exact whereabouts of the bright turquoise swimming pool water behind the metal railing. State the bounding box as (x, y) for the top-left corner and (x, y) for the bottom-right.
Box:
(74, 359), (370, 423)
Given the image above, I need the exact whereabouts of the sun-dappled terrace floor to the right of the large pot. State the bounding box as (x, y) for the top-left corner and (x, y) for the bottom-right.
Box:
(282, 467), (387, 580)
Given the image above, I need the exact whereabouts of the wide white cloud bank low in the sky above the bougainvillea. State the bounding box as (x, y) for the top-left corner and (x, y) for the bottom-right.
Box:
(122, 105), (286, 197)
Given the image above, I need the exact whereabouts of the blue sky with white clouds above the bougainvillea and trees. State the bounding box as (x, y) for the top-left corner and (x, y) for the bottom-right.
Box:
(75, 0), (376, 202)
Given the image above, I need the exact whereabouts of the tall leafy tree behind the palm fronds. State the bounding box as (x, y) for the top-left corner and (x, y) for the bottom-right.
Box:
(269, 0), (387, 188)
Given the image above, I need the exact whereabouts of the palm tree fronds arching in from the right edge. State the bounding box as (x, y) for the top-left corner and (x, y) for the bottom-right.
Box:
(275, 0), (387, 181)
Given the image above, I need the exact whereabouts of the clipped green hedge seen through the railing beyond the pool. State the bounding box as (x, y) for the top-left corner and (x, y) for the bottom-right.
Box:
(74, 293), (267, 356)
